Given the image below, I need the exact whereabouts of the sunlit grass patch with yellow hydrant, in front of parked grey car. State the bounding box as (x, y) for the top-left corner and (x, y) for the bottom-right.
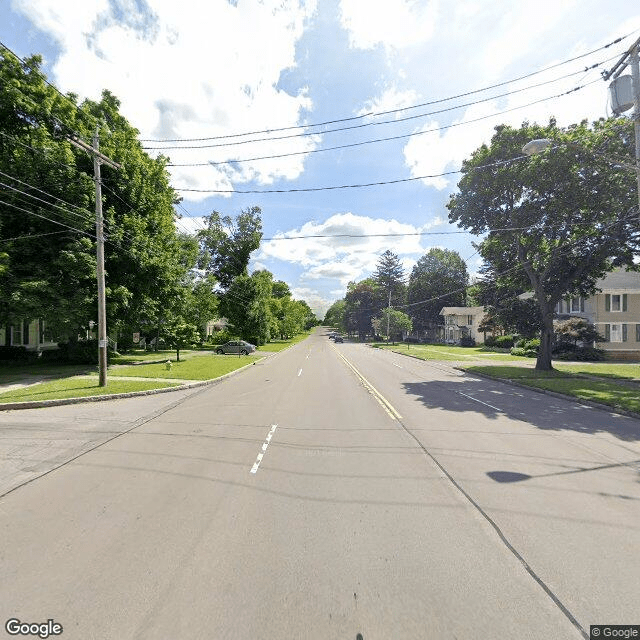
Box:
(109, 354), (259, 380)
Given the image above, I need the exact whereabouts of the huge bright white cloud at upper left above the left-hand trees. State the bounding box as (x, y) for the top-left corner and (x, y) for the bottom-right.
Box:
(14, 0), (317, 200)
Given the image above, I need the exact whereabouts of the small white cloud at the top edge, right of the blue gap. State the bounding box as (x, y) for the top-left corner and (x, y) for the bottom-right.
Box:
(340, 0), (438, 49)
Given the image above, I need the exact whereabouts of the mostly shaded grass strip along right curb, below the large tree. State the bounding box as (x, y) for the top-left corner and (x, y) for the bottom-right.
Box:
(464, 365), (640, 412)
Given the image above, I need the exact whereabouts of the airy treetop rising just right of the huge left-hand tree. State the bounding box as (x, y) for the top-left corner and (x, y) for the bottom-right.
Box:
(198, 207), (262, 289)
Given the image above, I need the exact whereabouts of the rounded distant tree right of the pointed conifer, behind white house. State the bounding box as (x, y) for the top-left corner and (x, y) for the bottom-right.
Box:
(407, 248), (469, 330)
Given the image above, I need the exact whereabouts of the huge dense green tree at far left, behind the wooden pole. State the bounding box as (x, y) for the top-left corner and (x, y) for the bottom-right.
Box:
(0, 52), (197, 348)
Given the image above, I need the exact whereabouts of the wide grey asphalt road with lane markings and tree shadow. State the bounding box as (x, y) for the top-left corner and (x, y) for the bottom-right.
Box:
(0, 330), (640, 640)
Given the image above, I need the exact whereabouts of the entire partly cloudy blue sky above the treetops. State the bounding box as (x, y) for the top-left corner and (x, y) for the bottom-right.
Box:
(0, 0), (640, 316)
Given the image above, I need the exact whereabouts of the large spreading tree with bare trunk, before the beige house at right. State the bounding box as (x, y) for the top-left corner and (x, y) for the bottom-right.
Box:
(447, 118), (640, 370)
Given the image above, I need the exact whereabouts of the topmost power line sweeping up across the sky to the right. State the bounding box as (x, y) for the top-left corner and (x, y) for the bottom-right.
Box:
(140, 31), (636, 148)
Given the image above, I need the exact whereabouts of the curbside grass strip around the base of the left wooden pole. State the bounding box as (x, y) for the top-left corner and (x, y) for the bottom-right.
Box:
(0, 377), (177, 404)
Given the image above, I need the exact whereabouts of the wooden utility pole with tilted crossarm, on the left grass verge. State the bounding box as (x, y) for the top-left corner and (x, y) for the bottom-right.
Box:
(69, 126), (120, 387)
